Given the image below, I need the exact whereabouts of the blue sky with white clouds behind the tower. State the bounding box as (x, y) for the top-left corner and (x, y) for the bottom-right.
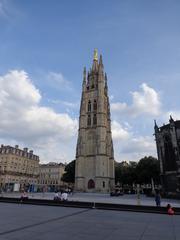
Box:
(0, 0), (180, 162)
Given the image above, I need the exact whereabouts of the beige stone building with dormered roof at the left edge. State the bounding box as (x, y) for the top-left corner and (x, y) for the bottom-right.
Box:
(0, 145), (39, 191)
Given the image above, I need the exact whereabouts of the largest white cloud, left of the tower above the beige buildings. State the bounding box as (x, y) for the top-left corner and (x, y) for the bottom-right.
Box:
(0, 70), (78, 160)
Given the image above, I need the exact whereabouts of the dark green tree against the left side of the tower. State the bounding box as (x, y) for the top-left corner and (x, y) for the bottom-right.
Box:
(61, 160), (75, 183)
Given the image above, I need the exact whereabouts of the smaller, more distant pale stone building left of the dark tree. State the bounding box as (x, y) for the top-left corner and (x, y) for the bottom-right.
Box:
(38, 162), (65, 191)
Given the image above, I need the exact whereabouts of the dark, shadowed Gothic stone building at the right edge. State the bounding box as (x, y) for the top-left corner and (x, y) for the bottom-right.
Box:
(154, 116), (180, 192)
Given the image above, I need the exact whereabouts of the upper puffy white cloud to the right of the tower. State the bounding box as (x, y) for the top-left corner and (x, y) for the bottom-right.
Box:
(111, 83), (161, 117)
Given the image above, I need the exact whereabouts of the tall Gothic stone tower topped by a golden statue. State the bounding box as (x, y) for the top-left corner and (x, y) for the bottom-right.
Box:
(75, 50), (114, 192)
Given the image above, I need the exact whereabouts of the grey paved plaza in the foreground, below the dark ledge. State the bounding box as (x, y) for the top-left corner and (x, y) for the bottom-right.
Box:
(0, 203), (180, 240)
